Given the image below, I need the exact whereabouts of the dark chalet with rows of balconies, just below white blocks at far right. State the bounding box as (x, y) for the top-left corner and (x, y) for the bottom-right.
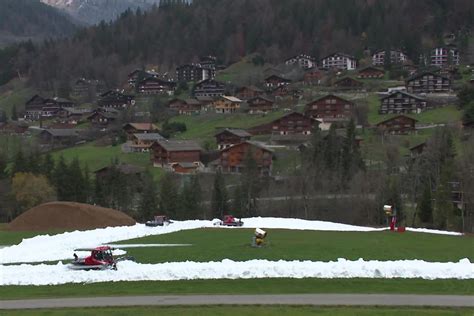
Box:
(406, 72), (451, 93)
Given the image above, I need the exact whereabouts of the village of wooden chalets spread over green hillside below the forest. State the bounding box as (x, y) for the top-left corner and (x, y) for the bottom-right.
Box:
(0, 36), (474, 230)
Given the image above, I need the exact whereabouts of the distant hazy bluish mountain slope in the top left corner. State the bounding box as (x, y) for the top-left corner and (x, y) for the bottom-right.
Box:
(0, 0), (77, 47)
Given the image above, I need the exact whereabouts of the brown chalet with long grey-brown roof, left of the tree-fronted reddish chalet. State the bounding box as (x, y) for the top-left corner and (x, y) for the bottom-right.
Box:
(151, 140), (202, 167)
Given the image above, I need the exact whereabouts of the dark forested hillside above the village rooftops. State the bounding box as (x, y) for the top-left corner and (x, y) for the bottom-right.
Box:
(3, 0), (474, 88)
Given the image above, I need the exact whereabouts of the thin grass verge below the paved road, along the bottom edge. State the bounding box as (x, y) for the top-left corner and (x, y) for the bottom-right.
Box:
(2, 306), (474, 316)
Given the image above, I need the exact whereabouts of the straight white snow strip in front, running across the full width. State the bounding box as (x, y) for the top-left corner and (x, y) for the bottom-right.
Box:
(0, 259), (474, 286)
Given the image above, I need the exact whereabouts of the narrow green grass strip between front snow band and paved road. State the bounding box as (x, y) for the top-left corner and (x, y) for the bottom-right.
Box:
(0, 279), (474, 300)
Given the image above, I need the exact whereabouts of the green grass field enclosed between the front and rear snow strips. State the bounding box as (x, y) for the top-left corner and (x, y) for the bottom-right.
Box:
(116, 228), (474, 263)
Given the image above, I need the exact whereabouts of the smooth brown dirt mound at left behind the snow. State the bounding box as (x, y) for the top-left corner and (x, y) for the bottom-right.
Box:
(8, 202), (135, 231)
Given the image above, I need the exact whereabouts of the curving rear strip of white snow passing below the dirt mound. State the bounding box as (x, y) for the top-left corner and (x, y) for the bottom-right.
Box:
(0, 217), (459, 264)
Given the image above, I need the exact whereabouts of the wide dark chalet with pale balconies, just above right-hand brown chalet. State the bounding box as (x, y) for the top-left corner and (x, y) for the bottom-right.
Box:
(379, 91), (427, 114)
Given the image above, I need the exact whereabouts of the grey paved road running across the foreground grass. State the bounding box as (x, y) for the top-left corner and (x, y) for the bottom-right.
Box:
(0, 294), (474, 309)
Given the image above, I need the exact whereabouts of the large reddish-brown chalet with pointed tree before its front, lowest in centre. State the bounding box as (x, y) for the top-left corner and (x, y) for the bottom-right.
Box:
(218, 141), (273, 175)
